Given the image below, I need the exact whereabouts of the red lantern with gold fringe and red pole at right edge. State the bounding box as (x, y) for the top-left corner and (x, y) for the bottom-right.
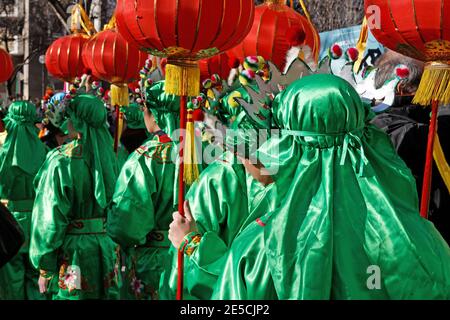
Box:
(365, 0), (450, 218)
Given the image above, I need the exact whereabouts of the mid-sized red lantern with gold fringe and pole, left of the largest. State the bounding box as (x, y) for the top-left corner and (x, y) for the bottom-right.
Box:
(82, 18), (147, 152)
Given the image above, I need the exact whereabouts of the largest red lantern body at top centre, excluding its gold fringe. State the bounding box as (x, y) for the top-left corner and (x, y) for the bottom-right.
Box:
(116, 0), (254, 60)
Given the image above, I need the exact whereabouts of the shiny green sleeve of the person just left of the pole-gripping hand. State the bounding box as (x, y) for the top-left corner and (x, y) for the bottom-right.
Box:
(107, 152), (156, 247)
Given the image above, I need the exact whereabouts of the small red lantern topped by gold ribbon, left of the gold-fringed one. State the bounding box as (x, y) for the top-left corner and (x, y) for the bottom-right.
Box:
(45, 4), (96, 82)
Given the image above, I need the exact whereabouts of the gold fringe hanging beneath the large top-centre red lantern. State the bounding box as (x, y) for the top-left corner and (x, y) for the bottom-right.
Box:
(165, 59), (200, 97)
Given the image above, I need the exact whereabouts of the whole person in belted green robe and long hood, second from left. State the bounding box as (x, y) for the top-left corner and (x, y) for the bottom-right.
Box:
(30, 94), (120, 300)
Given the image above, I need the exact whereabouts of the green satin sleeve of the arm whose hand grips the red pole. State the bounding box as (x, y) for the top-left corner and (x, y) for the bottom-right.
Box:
(185, 162), (248, 299)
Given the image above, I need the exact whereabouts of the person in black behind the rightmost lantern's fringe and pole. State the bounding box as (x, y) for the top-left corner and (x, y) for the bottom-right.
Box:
(373, 50), (450, 243)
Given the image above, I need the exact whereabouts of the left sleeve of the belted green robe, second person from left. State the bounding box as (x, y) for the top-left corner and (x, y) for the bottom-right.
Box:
(30, 158), (72, 272)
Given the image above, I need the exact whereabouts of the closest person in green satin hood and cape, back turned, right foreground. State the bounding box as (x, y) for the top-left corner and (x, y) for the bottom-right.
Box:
(213, 75), (450, 299)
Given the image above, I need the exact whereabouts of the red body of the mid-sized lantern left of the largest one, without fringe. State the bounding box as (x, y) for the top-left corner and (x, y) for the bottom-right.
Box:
(82, 29), (147, 85)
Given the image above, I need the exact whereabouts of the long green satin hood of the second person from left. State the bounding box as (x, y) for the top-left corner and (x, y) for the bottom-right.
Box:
(67, 94), (118, 208)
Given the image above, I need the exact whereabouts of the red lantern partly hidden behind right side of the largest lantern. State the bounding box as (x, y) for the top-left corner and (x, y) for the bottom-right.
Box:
(229, 0), (320, 70)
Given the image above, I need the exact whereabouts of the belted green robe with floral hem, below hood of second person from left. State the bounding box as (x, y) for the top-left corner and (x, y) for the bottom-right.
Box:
(30, 139), (120, 300)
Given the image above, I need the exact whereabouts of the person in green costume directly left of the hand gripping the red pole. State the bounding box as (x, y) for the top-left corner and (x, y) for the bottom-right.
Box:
(107, 81), (179, 299)
